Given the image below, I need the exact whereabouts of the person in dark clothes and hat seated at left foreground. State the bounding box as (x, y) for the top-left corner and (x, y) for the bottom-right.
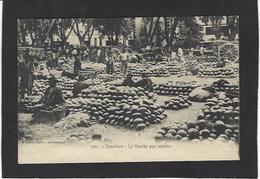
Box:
(37, 77), (65, 108)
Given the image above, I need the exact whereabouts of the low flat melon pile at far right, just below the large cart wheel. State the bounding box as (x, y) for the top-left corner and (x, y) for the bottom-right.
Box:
(198, 68), (236, 78)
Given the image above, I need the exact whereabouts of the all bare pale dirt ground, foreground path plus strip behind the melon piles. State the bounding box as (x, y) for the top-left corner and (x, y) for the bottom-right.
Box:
(18, 76), (238, 141)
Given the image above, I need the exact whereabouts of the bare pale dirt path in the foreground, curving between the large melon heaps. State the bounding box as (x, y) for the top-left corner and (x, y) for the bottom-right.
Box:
(19, 101), (203, 142)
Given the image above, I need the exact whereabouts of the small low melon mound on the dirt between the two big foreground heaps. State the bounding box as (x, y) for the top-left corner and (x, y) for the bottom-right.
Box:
(162, 95), (192, 110)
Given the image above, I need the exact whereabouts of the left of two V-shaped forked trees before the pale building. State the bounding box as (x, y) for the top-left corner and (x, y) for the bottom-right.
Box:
(53, 19), (75, 45)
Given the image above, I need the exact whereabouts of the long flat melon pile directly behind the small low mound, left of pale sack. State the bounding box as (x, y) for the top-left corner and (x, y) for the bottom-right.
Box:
(154, 83), (194, 96)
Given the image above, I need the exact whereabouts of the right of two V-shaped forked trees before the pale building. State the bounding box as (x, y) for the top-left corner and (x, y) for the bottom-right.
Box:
(72, 18), (95, 47)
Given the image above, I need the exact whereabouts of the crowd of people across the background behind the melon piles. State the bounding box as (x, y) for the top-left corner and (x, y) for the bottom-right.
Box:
(17, 43), (213, 105)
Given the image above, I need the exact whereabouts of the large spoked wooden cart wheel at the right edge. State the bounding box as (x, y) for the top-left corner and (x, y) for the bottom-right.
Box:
(218, 42), (239, 63)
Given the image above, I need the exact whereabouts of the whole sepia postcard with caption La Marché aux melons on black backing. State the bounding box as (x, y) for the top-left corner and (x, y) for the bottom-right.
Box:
(17, 15), (240, 164)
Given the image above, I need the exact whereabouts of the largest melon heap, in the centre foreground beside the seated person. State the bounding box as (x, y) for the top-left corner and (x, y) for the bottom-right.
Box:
(67, 85), (166, 130)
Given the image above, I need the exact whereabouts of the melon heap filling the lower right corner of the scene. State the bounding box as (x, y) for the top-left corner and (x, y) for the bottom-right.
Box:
(155, 96), (239, 142)
